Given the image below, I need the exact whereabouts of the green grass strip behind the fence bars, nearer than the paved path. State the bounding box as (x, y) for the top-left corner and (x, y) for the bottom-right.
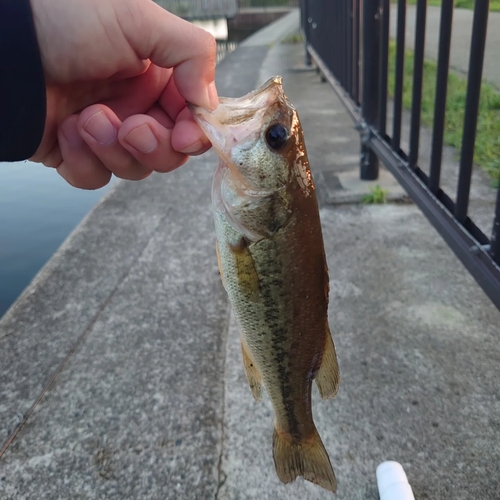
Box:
(389, 42), (500, 184)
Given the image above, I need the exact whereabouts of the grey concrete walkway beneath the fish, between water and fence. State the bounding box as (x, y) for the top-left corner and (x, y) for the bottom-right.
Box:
(0, 8), (500, 500)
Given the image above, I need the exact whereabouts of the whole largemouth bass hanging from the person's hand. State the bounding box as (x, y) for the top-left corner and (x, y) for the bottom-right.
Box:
(191, 77), (340, 492)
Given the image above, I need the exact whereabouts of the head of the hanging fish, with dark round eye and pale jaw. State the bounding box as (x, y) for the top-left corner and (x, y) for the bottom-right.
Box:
(190, 77), (310, 193)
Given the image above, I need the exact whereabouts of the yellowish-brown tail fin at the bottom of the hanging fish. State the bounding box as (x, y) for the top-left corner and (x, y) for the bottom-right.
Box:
(273, 429), (337, 493)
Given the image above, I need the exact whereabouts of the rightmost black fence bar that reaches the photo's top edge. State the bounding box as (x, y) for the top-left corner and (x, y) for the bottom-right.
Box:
(455, 0), (490, 224)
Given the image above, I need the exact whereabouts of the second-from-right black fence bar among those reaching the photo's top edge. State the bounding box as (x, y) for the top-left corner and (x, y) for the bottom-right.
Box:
(429, 0), (455, 194)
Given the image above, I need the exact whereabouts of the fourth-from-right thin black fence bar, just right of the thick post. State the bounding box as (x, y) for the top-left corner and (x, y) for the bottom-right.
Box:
(391, 0), (406, 151)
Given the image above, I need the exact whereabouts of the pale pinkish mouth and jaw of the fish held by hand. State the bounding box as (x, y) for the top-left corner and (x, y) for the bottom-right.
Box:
(188, 76), (288, 182)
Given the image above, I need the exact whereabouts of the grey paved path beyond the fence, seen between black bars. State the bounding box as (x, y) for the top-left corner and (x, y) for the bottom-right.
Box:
(391, 4), (500, 88)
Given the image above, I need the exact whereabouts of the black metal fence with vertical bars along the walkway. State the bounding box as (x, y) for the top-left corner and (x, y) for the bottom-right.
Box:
(301, 0), (500, 309)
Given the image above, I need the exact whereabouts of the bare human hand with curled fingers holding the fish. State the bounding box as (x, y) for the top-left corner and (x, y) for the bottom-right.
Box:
(31, 0), (218, 189)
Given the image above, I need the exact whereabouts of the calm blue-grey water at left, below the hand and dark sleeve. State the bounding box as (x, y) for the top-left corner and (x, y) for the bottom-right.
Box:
(0, 162), (110, 317)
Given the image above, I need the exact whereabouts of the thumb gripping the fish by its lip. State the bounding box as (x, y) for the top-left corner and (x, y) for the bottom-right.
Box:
(117, 0), (219, 109)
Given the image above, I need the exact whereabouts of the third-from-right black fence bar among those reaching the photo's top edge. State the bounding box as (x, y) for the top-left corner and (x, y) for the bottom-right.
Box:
(408, 0), (427, 168)
